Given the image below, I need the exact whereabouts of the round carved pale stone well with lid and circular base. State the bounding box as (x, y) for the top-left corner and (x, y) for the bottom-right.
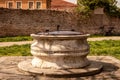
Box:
(18, 31), (102, 76)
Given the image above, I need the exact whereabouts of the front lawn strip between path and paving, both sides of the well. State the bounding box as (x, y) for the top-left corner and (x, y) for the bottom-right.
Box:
(0, 40), (120, 59)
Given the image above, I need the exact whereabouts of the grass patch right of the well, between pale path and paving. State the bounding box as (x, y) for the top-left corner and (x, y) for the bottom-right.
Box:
(89, 40), (120, 59)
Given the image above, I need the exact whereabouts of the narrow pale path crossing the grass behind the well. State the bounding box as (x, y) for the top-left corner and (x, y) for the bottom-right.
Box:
(0, 36), (120, 47)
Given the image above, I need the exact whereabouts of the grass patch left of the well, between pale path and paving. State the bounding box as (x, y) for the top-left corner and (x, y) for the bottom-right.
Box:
(0, 44), (31, 56)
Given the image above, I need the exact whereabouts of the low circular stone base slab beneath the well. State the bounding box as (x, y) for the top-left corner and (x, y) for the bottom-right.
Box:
(18, 60), (103, 77)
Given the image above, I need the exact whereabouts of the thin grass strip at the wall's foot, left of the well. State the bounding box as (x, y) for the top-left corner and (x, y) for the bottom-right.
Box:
(0, 36), (32, 42)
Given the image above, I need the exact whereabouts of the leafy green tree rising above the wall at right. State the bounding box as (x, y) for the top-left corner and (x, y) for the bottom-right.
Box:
(77, 0), (120, 17)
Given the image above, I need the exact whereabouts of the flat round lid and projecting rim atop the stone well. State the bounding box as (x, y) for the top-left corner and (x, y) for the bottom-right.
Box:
(31, 31), (89, 39)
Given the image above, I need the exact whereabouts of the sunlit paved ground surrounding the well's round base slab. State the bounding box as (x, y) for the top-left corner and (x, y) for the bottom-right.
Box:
(0, 56), (120, 80)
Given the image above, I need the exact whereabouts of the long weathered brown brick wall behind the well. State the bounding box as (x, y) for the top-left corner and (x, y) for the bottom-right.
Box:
(0, 8), (120, 37)
